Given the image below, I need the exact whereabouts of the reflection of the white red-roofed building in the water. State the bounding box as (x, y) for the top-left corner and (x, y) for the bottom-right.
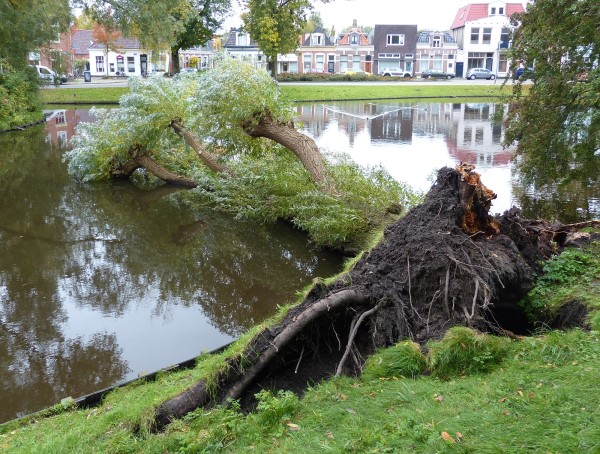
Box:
(446, 103), (513, 168)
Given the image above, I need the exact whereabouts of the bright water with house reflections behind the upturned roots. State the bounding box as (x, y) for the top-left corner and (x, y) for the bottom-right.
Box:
(297, 100), (600, 222)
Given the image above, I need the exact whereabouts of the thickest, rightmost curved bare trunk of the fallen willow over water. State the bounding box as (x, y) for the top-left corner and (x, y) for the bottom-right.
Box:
(245, 113), (334, 193)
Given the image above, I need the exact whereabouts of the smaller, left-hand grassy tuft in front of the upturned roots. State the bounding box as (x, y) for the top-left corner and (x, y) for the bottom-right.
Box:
(362, 341), (426, 380)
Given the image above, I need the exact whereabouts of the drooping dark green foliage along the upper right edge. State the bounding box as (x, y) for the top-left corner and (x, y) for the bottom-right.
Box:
(505, 0), (600, 189)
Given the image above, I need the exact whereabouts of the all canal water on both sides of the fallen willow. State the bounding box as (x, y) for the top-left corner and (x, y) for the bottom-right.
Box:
(0, 101), (600, 423)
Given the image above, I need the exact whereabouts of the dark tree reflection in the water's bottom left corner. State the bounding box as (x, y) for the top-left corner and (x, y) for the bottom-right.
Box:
(0, 328), (128, 423)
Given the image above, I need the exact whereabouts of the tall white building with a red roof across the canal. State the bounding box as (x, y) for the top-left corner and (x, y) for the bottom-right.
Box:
(451, 1), (525, 77)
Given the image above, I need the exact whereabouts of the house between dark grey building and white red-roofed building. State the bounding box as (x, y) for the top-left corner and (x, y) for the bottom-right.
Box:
(415, 31), (458, 74)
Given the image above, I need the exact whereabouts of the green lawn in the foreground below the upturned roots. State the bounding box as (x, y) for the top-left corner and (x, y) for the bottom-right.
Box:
(0, 330), (600, 453)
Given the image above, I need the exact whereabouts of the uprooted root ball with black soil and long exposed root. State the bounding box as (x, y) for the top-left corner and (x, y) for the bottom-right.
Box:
(155, 165), (599, 429)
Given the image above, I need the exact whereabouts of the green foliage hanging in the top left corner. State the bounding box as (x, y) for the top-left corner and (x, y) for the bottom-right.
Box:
(0, 0), (71, 69)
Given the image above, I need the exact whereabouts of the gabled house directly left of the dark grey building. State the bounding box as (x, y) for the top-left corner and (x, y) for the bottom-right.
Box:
(336, 19), (373, 73)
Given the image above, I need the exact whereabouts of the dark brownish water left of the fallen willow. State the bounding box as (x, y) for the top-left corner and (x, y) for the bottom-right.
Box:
(0, 111), (341, 422)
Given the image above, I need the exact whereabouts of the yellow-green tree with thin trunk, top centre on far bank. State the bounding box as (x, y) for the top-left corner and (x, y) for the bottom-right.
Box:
(242, 0), (312, 78)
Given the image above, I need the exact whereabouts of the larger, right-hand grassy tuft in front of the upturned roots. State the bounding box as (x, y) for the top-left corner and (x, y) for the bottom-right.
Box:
(428, 326), (510, 378)
